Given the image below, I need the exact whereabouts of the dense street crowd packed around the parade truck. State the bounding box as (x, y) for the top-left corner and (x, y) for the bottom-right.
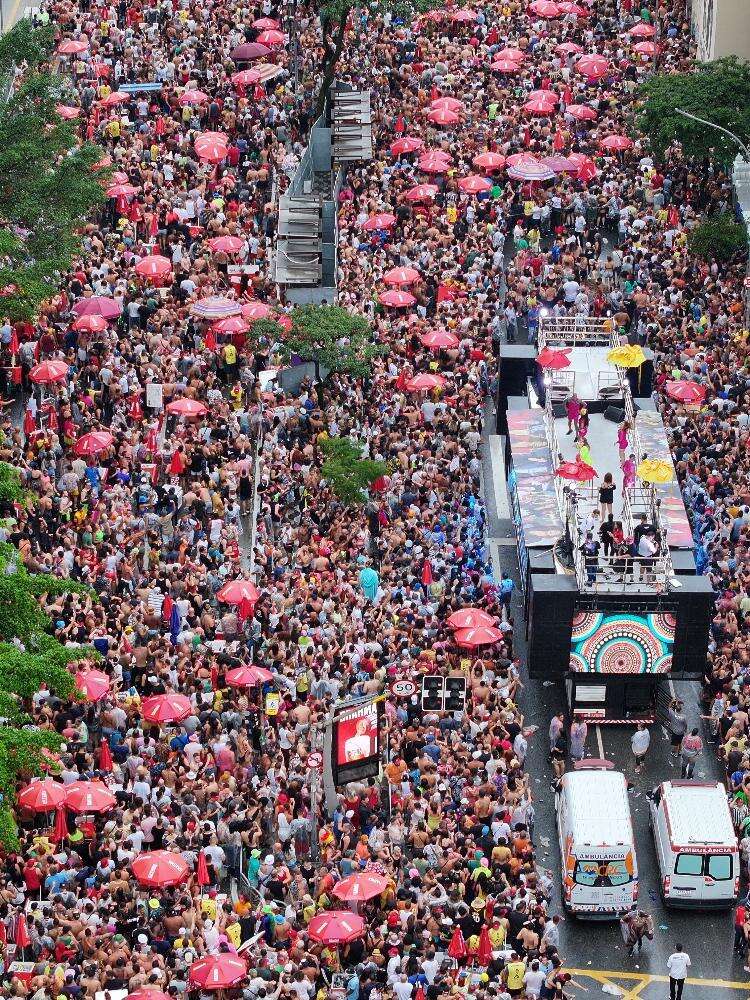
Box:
(0, 0), (750, 1000)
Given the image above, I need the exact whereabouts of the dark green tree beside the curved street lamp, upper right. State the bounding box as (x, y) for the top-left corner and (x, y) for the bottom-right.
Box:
(638, 56), (750, 163)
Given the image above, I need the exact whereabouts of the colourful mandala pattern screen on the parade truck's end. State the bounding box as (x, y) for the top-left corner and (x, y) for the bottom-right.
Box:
(570, 612), (676, 674)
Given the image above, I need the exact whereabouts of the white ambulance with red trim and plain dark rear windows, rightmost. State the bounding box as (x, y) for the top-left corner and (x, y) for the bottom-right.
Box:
(649, 781), (740, 909)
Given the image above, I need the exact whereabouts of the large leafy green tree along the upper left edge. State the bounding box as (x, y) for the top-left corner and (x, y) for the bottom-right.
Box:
(0, 26), (105, 320)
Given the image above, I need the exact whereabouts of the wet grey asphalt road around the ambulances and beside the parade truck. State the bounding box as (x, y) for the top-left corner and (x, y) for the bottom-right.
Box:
(483, 404), (750, 1000)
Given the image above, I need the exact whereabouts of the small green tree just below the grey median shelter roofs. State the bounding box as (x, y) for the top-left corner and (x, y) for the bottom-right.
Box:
(281, 305), (385, 409)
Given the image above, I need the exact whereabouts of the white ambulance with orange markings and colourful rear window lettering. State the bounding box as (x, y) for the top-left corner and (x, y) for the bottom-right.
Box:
(555, 761), (638, 920)
